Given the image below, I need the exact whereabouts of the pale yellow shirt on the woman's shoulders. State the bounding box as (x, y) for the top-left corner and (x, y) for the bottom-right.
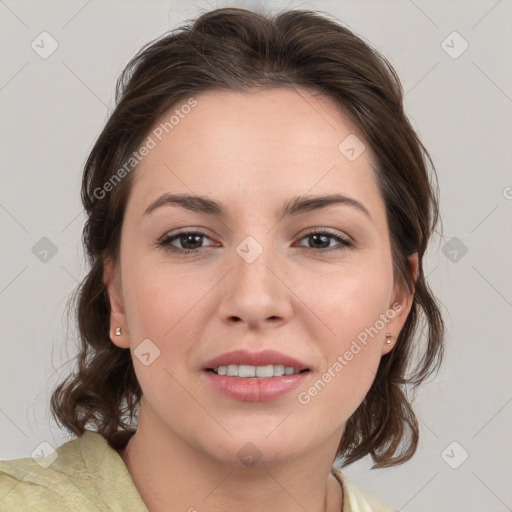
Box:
(0, 431), (393, 512)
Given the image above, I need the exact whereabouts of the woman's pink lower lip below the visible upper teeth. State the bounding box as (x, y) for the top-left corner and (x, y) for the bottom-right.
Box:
(204, 371), (310, 402)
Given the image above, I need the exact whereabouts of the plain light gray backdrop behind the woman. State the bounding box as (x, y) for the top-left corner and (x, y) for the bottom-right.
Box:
(0, 0), (512, 512)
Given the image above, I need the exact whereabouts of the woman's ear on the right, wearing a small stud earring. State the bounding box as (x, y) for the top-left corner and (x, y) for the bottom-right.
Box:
(382, 252), (419, 355)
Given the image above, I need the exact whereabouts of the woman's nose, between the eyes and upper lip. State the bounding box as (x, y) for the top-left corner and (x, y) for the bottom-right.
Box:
(219, 242), (293, 330)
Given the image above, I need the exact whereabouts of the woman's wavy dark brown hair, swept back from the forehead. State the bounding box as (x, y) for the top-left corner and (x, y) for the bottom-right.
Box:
(51, 8), (444, 467)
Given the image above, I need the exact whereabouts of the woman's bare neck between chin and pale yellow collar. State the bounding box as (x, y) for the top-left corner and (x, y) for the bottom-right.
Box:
(119, 406), (342, 512)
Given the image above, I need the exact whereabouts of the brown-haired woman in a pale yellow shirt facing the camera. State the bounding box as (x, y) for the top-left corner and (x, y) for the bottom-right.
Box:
(0, 8), (443, 512)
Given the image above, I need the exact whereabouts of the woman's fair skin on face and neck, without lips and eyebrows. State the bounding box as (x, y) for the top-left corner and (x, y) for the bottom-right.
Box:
(104, 88), (418, 512)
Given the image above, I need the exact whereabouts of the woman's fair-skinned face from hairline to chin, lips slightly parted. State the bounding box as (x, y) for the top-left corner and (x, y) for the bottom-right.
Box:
(105, 89), (417, 465)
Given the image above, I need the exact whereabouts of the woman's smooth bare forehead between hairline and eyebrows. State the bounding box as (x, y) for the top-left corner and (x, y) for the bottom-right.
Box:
(130, 88), (382, 222)
